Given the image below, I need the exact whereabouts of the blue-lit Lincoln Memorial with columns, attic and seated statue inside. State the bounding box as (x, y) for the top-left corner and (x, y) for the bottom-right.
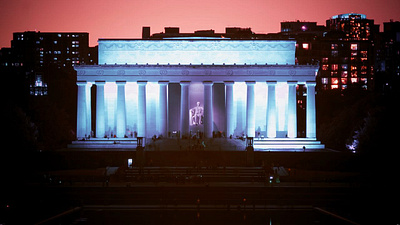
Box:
(75, 38), (324, 150)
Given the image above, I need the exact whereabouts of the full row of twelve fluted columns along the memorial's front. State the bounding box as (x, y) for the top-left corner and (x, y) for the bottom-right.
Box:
(77, 81), (316, 138)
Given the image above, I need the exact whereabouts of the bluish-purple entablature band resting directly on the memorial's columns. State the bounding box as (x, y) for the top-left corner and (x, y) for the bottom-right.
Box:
(74, 64), (319, 83)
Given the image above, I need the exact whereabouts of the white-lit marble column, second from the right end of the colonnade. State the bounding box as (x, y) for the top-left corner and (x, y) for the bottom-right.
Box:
(287, 81), (297, 138)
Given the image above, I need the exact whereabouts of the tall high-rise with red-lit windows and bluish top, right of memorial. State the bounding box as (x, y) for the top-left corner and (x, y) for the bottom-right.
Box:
(319, 13), (379, 90)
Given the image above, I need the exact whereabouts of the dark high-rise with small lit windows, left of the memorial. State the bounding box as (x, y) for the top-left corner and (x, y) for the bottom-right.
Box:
(0, 31), (97, 96)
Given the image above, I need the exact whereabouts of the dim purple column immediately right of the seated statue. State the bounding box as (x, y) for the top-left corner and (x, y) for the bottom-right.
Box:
(203, 81), (214, 138)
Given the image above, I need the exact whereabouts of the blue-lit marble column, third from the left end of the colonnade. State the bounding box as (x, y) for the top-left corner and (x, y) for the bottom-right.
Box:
(115, 81), (126, 137)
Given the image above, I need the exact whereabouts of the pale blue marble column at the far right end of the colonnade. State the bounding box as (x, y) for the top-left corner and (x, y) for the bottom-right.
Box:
(306, 81), (317, 138)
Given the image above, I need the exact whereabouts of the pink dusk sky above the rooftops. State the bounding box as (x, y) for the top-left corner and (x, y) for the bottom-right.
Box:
(0, 0), (400, 47)
